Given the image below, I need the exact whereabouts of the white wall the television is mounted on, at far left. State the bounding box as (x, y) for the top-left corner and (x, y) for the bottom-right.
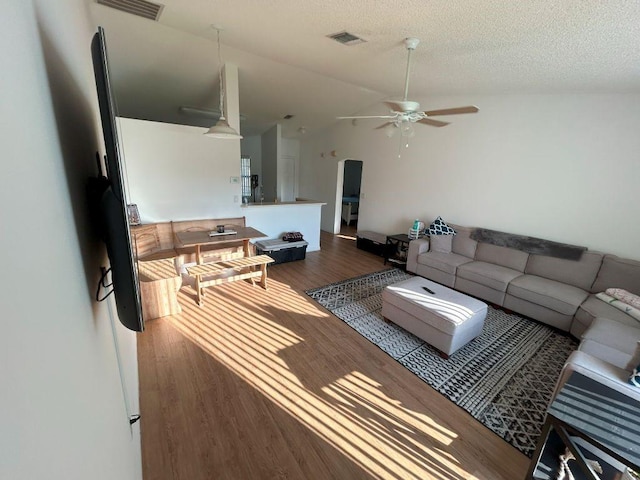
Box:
(0, 0), (142, 480)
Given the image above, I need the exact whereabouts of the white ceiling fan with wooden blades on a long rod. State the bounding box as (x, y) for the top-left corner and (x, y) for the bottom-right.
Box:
(337, 38), (478, 136)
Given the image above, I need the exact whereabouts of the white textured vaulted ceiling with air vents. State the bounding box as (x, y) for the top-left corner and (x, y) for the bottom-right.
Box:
(87, 0), (640, 136)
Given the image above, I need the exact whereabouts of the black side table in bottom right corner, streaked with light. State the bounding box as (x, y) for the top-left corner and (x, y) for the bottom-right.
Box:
(527, 373), (640, 480)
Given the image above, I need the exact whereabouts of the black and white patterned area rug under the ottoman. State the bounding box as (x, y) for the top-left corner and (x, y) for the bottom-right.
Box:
(306, 269), (577, 457)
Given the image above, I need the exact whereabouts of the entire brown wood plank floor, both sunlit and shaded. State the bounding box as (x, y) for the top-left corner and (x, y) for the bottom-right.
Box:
(138, 234), (529, 480)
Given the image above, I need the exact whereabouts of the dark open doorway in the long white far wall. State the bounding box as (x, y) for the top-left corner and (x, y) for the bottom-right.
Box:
(336, 159), (364, 237)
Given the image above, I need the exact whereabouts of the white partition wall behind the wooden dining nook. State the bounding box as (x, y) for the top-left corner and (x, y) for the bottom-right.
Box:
(119, 118), (242, 223)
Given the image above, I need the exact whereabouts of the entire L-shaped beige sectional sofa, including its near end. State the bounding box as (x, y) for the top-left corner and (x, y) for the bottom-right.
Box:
(407, 225), (640, 399)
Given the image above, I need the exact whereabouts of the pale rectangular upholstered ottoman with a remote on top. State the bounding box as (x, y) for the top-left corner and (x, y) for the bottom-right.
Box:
(382, 277), (487, 358)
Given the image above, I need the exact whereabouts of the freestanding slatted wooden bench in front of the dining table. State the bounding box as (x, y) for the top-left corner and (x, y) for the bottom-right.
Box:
(187, 252), (274, 305)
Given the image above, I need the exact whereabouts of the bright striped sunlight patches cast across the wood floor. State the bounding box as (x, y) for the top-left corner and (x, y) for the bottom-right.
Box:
(162, 281), (482, 480)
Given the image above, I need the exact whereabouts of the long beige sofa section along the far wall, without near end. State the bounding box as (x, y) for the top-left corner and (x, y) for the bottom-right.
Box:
(407, 225), (640, 338)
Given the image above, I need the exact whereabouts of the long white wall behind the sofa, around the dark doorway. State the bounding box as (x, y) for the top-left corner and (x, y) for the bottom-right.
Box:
(300, 94), (640, 258)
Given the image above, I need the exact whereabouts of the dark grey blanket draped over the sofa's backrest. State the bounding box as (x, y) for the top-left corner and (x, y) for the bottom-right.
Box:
(470, 228), (587, 260)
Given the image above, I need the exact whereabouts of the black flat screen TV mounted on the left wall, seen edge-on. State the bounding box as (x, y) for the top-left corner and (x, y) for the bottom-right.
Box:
(91, 27), (144, 332)
